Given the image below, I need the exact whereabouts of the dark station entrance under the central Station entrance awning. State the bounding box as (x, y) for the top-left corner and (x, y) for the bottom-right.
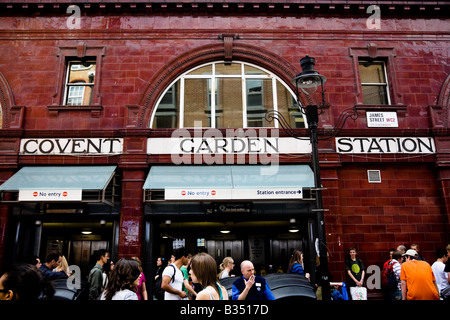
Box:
(148, 218), (309, 275)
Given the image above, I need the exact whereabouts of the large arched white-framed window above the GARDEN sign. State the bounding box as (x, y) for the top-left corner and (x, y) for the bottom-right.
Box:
(150, 62), (306, 129)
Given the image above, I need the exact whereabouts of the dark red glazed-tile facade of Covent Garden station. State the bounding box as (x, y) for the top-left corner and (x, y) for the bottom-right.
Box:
(0, 0), (450, 298)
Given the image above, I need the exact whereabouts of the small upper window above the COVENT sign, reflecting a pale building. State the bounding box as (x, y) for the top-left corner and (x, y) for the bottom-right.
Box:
(64, 61), (96, 106)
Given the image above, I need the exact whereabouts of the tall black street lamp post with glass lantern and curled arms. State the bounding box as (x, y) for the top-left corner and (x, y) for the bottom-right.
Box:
(266, 56), (358, 300)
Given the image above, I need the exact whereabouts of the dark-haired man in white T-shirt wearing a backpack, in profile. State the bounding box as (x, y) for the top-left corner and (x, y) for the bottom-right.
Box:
(161, 248), (188, 300)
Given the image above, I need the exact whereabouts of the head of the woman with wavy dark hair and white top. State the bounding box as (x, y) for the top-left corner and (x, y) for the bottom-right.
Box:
(105, 258), (141, 300)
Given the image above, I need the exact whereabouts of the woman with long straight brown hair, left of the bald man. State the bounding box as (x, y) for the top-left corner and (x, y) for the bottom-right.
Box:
(189, 252), (228, 300)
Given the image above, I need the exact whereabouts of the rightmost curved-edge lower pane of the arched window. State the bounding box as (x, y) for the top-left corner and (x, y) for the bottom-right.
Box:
(277, 80), (305, 128)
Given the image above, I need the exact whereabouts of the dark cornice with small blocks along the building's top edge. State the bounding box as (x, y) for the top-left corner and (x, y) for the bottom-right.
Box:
(0, 0), (450, 17)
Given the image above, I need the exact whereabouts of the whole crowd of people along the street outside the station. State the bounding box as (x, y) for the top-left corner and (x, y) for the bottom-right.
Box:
(0, 245), (450, 300)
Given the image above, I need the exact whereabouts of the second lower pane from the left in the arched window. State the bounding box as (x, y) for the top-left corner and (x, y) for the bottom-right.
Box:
(183, 79), (212, 127)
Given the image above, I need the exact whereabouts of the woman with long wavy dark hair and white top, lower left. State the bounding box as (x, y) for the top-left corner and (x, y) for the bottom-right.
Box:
(100, 258), (141, 300)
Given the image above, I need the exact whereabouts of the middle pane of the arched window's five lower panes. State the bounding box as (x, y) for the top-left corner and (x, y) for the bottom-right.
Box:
(216, 78), (243, 128)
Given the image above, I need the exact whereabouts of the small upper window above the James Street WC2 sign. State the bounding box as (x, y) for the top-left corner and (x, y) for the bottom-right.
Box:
(359, 59), (390, 105)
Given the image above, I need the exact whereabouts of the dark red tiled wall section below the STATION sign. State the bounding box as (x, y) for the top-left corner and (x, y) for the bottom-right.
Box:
(324, 163), (447, 280)
